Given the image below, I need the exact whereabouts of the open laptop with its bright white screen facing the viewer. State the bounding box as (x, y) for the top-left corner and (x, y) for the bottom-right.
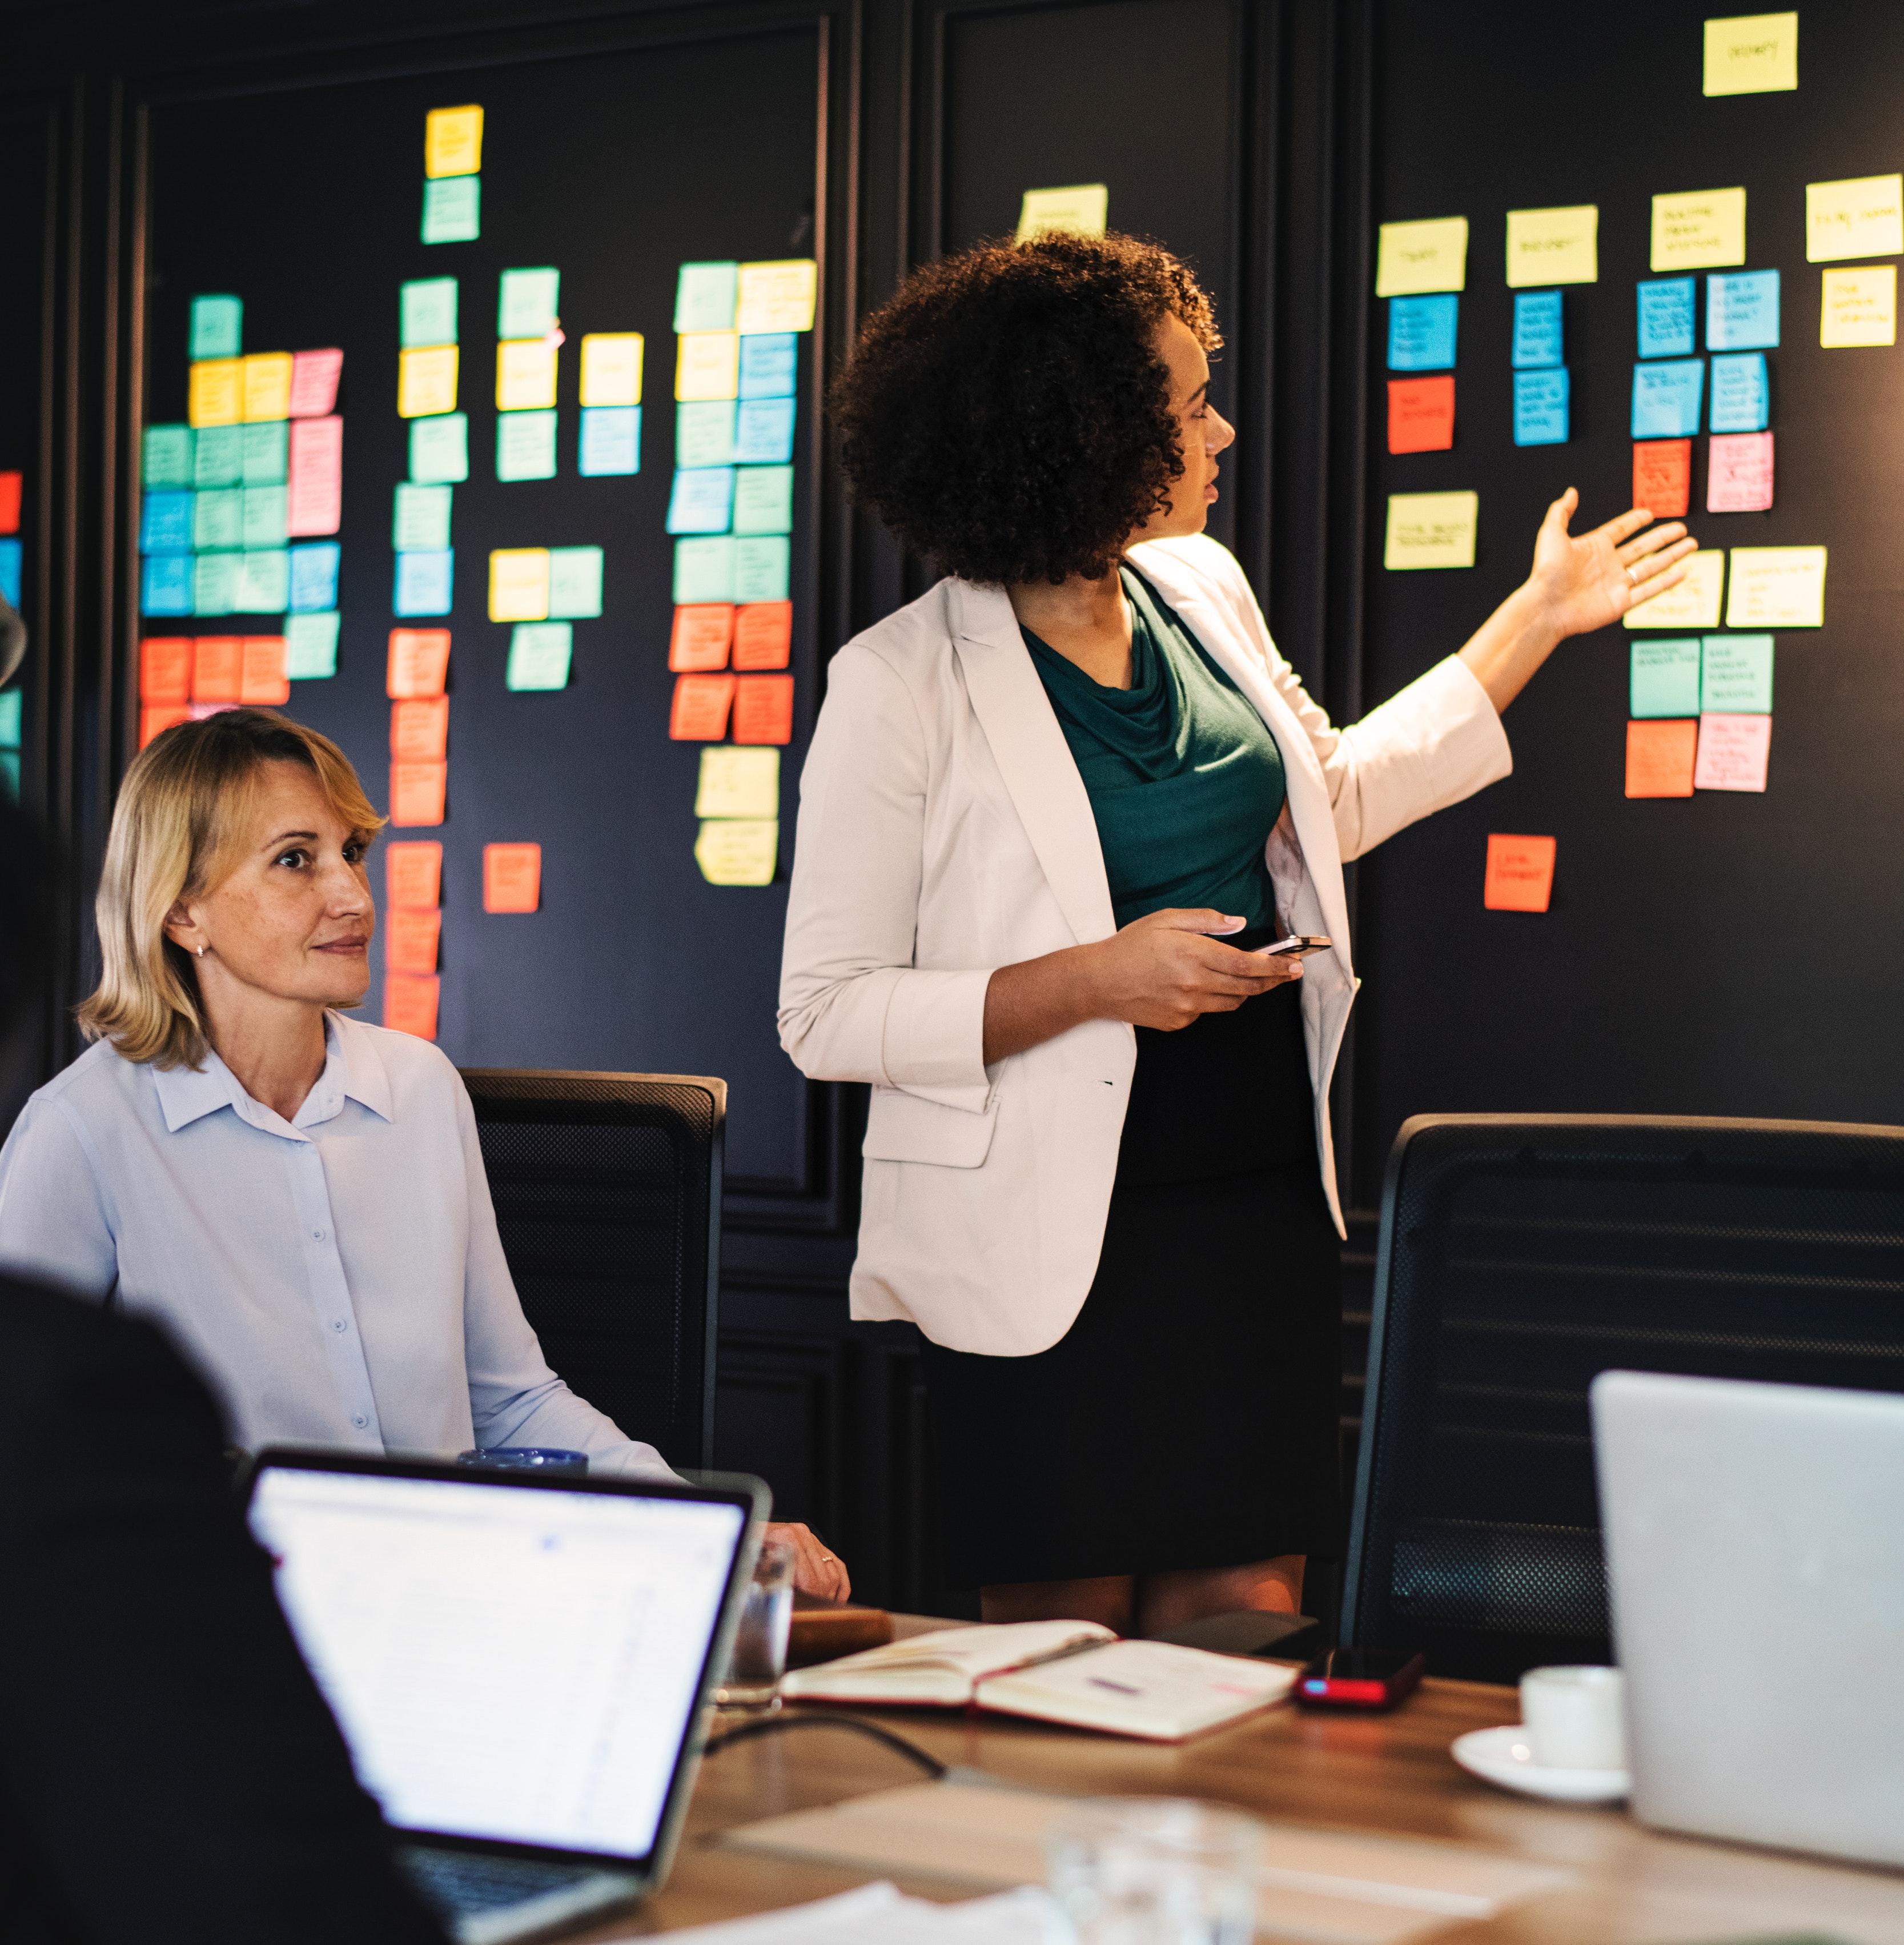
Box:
(249, 1449), (768, 1945)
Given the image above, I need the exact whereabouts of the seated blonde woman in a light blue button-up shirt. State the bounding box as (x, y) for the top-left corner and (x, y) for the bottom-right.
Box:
(0, 710), (848, 1597)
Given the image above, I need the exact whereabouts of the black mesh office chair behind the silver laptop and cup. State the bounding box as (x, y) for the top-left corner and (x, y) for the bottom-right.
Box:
(1342, 1114), (1904, 1681)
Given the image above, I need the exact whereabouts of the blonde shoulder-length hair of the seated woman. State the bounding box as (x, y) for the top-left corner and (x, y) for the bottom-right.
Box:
(78, 710), (383, 1068)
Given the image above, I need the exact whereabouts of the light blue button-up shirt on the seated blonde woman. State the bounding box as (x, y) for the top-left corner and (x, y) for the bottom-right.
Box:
(0, 1013), (671, 1476)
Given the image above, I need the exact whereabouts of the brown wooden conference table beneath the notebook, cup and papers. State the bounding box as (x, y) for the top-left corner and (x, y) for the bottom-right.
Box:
(577, 1617), (1904, 1945)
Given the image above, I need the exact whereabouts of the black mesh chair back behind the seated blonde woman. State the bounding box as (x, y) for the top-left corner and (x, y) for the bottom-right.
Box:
(463, 1068), (728, 1466)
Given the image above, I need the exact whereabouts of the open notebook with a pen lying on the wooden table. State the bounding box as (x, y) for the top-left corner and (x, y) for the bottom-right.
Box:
(780, 1620), (1297, 1743)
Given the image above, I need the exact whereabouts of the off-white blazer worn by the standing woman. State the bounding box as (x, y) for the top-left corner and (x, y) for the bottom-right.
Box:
(780, 535), (1513, 1358)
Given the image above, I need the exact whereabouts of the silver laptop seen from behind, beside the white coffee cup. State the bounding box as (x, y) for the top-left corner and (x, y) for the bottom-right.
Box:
(1591, 1371), (1904, 1865)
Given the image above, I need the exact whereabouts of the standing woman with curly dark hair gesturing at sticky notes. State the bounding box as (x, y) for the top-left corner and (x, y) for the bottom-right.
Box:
(780, 235), (1694, 1634)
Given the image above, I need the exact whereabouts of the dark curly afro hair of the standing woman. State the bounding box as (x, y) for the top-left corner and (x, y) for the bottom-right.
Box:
(829, 235), (1223, 584)
